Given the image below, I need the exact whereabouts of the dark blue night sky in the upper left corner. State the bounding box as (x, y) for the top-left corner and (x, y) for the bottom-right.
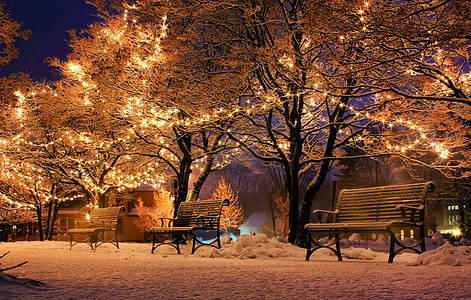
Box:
(0, 0), (98, 80)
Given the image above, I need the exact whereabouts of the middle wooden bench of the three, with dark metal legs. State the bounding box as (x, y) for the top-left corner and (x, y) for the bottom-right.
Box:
(150, 199), (229, 254)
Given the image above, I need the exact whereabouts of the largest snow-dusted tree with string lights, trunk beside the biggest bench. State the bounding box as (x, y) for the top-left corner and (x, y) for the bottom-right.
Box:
(172, 0), (469, 244)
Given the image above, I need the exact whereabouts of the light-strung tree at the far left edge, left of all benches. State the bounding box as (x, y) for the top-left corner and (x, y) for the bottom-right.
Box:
(0, 77), (81, 240)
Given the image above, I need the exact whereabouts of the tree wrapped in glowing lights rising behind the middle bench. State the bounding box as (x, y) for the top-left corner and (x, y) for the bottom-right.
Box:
(48, 2), (240, 213)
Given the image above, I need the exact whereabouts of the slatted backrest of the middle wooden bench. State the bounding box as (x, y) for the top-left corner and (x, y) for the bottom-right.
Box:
(173, 199), (229, 227)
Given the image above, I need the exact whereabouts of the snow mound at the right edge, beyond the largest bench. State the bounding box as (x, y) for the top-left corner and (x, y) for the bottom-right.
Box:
(408, 243), (471, 266)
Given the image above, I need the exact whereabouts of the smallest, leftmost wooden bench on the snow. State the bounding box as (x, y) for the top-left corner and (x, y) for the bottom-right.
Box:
(67, 207), (124, 250)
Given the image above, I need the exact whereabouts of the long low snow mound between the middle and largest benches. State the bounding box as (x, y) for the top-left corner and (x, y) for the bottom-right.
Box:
(199, 234), (306, 259)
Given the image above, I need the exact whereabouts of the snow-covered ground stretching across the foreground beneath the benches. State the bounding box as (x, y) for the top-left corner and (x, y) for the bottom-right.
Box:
(0, 235), (471, 299)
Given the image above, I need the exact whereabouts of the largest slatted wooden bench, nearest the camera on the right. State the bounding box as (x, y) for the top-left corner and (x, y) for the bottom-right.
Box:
(304, 182), (435, 263)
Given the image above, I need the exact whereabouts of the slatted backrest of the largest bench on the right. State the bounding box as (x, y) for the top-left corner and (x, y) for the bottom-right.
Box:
(337, 182), (435, 223)
